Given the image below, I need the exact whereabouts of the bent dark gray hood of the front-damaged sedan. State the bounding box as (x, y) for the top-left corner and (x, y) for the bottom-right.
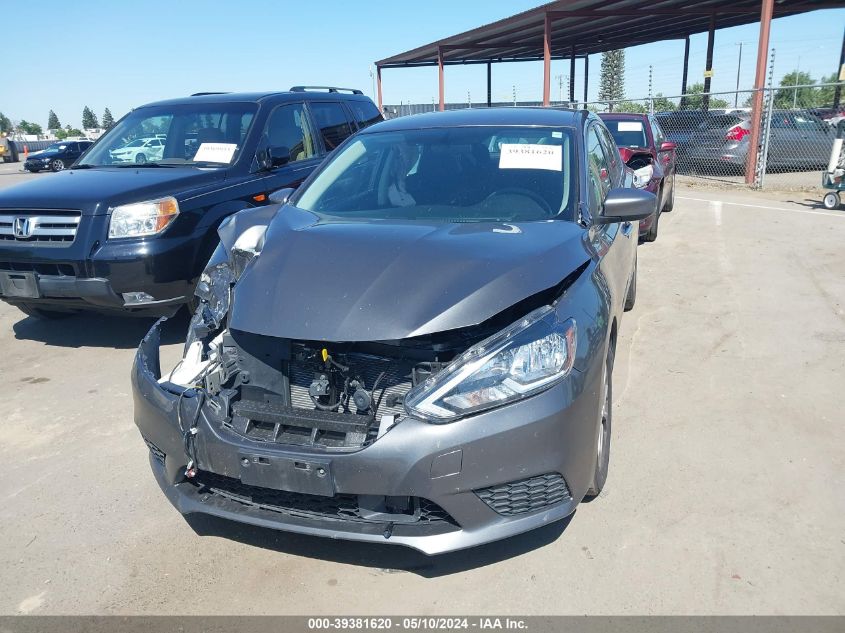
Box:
(229, 206), (590, 342)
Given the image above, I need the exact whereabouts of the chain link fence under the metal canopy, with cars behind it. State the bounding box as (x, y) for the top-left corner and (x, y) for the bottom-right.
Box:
(388, 83), (845, 190)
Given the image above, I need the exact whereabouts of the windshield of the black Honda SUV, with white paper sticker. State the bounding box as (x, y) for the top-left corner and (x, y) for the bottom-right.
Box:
(77, 103), (257, 167)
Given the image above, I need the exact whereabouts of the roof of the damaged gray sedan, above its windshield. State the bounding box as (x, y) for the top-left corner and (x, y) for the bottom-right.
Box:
(360, 108), (588, 134)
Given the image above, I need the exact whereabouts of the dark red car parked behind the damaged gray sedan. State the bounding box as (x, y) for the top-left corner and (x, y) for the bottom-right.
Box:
(599, 112), (676, 242)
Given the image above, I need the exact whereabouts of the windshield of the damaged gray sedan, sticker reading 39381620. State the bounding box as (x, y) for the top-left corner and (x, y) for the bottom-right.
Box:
(294, 126), (576, 222)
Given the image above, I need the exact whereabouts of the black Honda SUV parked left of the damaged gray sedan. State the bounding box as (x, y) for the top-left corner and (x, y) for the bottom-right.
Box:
(0, 86), (382, 317)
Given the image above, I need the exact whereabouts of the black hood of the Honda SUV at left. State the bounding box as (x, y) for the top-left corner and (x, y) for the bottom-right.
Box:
(0, 167), (225, 215)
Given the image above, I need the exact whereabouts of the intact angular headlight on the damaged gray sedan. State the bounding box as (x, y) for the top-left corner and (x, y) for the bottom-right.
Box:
(405, 306), (576, 423)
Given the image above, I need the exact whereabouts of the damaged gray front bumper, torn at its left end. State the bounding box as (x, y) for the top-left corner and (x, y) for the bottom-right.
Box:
(132, 321), (601, 555)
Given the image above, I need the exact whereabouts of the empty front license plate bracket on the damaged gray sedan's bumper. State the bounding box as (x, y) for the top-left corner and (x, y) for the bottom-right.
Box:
(239, 453), (335, 497)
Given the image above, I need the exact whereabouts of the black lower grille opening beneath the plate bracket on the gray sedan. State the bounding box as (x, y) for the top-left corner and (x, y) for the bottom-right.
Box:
(188, 471), (458, 527)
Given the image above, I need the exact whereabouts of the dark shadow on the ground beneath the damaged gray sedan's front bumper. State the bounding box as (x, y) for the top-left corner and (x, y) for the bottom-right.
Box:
(185, 513), (574, 578)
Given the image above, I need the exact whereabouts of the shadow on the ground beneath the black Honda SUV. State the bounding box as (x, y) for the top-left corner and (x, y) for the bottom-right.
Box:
(12, 310), (188, 349)
